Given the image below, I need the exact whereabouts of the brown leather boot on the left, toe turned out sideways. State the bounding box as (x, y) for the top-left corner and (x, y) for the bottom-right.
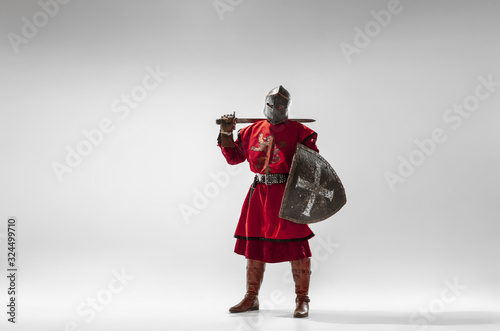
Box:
(229, 259), (266, 313)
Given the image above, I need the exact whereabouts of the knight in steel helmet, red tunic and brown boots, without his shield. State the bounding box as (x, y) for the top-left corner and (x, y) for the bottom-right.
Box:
(218, 86), (318, 317)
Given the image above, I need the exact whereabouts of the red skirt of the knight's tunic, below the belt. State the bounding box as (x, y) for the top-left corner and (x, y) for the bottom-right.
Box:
(234, 183), (314, 263)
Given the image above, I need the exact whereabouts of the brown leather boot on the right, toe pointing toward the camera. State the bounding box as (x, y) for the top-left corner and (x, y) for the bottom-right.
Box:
(291, 257), (311, 317)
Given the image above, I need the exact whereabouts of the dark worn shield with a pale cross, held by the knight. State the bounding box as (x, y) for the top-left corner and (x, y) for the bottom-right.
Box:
(279, 144), (347, 224)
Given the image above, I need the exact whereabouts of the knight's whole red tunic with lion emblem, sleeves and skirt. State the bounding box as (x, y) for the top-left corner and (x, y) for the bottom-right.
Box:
(221, 120), (318, 262)
